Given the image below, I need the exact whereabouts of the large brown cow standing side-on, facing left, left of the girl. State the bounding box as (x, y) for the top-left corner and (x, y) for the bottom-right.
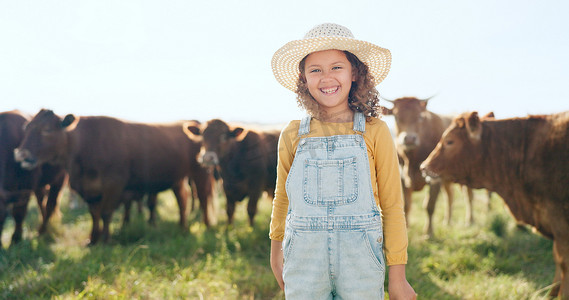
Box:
(15, 109), (213, 245)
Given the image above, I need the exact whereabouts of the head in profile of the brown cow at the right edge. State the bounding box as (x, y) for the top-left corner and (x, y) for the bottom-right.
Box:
(421, 112), (484, 184)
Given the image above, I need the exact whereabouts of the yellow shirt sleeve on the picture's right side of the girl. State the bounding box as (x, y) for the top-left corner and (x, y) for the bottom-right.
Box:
(374, 122), (408, 265)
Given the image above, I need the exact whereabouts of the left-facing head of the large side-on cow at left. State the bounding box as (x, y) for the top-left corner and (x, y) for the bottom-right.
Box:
(14, 109), (79, 170)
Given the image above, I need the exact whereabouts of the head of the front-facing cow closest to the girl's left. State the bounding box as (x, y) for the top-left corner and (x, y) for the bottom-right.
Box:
(185, 119), (246, 166)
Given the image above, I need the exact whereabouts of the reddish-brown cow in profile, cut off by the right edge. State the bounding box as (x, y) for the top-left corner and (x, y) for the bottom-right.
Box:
(421, 111), (569, 299)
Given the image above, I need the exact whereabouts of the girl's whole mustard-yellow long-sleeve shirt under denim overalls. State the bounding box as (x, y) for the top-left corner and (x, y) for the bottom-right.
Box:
(269, 118), (407, 265)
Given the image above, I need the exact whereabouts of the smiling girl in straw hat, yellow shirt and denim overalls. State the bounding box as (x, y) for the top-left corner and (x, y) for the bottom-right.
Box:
(270, 24), (416, 299)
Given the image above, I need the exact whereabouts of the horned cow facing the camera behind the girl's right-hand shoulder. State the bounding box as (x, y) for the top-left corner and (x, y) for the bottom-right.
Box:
(383, 97), (474, 237)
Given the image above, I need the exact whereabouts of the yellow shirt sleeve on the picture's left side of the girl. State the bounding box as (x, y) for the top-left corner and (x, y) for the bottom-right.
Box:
(269, 121), (299, 241)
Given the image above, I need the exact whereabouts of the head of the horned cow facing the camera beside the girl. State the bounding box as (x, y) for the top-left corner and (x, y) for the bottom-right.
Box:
(383, 97), (430, 151)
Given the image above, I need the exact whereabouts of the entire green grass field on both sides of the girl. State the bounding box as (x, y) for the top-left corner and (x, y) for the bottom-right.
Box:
(0, 186), (555, 299)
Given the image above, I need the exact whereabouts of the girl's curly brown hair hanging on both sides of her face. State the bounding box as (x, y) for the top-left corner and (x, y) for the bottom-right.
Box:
(296, 51), (381, 119)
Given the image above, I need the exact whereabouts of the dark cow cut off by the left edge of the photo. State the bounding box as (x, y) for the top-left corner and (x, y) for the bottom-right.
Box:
(0, 110), (67, 248)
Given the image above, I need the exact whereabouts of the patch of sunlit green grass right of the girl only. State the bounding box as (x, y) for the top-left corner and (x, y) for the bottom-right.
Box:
(407, 191), (555, 299)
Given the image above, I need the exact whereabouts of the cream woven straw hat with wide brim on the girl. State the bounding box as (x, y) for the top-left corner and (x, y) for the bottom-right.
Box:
(271, 23), (391, 92)
